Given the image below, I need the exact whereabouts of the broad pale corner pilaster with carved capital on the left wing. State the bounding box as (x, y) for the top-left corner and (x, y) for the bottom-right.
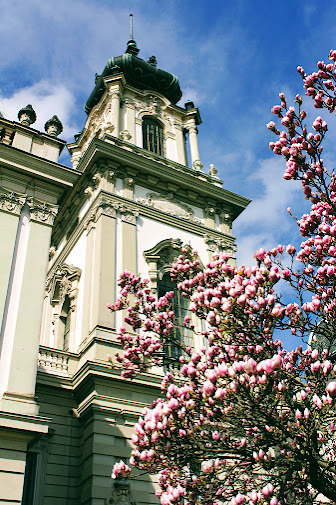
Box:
(0, 201), (56, 415)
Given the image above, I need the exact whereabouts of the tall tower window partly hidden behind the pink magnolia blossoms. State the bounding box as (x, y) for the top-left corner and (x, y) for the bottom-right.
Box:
(158, 273), (193, 359)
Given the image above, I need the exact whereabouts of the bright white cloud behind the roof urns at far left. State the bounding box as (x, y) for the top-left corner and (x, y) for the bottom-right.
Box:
(0, 80), (78, 140)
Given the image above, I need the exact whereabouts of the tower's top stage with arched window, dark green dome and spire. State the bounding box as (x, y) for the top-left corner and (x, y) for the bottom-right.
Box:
(68, 15), (203, 172)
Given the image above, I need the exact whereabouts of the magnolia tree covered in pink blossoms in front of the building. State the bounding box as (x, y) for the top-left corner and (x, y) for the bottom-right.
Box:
(111, 51), (336, 505)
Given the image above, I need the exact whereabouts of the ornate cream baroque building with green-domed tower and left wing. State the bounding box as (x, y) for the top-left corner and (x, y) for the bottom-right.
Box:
(0, 36), (249, 505)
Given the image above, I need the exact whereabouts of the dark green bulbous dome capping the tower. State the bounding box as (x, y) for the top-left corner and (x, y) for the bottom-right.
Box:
(84, 40), (182, 114)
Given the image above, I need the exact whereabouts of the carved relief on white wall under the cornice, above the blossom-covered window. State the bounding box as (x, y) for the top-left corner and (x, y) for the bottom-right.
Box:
(138, 193), (201, 223)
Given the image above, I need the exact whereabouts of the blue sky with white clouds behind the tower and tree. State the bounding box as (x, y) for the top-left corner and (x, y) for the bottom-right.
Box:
(0, 0), (336, 272)
